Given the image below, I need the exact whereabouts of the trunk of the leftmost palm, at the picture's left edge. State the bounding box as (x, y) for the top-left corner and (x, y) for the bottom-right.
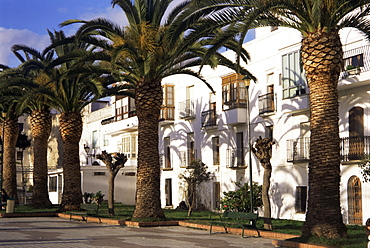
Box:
(3, 118), (19, 204)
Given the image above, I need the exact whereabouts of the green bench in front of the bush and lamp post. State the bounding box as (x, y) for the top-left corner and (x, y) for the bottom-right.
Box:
(209, 211), (261, 238)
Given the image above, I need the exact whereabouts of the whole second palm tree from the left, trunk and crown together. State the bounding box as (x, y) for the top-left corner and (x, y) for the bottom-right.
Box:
(8, 42), (55, 208)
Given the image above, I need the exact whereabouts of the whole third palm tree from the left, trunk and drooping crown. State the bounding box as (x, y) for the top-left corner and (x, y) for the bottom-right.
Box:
(43, 31), (127, 211)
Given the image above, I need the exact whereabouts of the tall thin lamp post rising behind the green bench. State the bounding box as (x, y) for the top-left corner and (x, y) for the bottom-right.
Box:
(243, 75), (253, 212)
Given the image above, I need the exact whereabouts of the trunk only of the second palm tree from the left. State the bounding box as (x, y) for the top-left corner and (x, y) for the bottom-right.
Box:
(30, 110), (52, 208)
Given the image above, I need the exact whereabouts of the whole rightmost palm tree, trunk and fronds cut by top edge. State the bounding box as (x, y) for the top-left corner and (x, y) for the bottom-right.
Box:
(185, 0), (370, 238)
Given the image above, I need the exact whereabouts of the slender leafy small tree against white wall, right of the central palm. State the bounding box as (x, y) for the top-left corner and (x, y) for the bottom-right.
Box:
(180, 160), (211, 216)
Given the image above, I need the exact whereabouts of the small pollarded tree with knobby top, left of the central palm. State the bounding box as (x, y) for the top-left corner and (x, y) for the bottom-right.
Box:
(97, 151), (127, 216)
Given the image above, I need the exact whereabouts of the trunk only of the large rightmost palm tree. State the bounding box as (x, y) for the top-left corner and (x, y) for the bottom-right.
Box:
(302, 32), (347, 238)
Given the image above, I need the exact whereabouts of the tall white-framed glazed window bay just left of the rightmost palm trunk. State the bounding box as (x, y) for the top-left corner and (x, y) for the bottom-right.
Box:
(282, 51), (307, 98)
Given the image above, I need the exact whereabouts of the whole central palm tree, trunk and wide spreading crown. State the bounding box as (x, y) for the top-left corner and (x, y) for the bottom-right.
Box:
(61, 0), (251, 218)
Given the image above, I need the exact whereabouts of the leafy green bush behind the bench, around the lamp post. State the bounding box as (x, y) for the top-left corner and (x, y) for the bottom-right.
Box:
(221, 182), (263, 212)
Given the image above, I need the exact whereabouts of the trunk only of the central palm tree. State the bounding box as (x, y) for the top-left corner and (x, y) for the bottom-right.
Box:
(133, 82), (164, 218)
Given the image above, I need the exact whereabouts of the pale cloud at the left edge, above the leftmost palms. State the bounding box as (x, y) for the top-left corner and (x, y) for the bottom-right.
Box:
(0, 27), (49, 67)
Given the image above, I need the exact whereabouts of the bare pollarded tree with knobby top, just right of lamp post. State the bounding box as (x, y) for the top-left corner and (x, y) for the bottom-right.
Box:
(252, 136), (275, 230)
